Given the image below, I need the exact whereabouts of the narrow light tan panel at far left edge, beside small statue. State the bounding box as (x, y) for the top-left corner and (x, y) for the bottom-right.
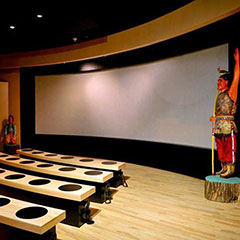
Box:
(0, 82), (8, 151)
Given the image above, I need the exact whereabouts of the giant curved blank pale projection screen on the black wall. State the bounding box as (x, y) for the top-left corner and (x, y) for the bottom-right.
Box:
(35, 44), (228, 148)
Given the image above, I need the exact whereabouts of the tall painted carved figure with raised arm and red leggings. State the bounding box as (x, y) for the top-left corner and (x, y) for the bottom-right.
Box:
(210, 49), (239, 178)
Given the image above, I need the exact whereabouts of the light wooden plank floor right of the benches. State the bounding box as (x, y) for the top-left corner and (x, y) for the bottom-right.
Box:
(57, 164), (240, 240)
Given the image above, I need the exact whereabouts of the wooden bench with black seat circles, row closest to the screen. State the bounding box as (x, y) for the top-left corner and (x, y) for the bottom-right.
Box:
(17, 148), (127, 187)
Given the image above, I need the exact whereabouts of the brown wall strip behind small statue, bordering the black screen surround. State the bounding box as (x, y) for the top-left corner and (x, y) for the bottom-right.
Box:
(0, 69), (21, 144)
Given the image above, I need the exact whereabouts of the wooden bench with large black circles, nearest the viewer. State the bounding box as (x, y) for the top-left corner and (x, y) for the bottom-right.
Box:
(0, 195), (66, 240)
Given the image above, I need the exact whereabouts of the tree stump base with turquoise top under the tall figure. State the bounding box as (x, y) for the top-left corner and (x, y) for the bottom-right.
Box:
(205, 175), (240, 203)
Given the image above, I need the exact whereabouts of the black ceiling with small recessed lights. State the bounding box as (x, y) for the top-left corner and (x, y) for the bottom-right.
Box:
(0, 0), (192, 54)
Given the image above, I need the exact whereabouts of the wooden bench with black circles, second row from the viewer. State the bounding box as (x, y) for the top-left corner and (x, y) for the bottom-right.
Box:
(0, 168), (95, 227)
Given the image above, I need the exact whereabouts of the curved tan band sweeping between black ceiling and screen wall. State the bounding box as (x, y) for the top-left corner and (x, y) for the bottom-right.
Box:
(0, 0), (240, 68)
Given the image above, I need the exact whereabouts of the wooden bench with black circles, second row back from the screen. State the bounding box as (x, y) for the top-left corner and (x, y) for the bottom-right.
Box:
(0, 152), (113, 202)
